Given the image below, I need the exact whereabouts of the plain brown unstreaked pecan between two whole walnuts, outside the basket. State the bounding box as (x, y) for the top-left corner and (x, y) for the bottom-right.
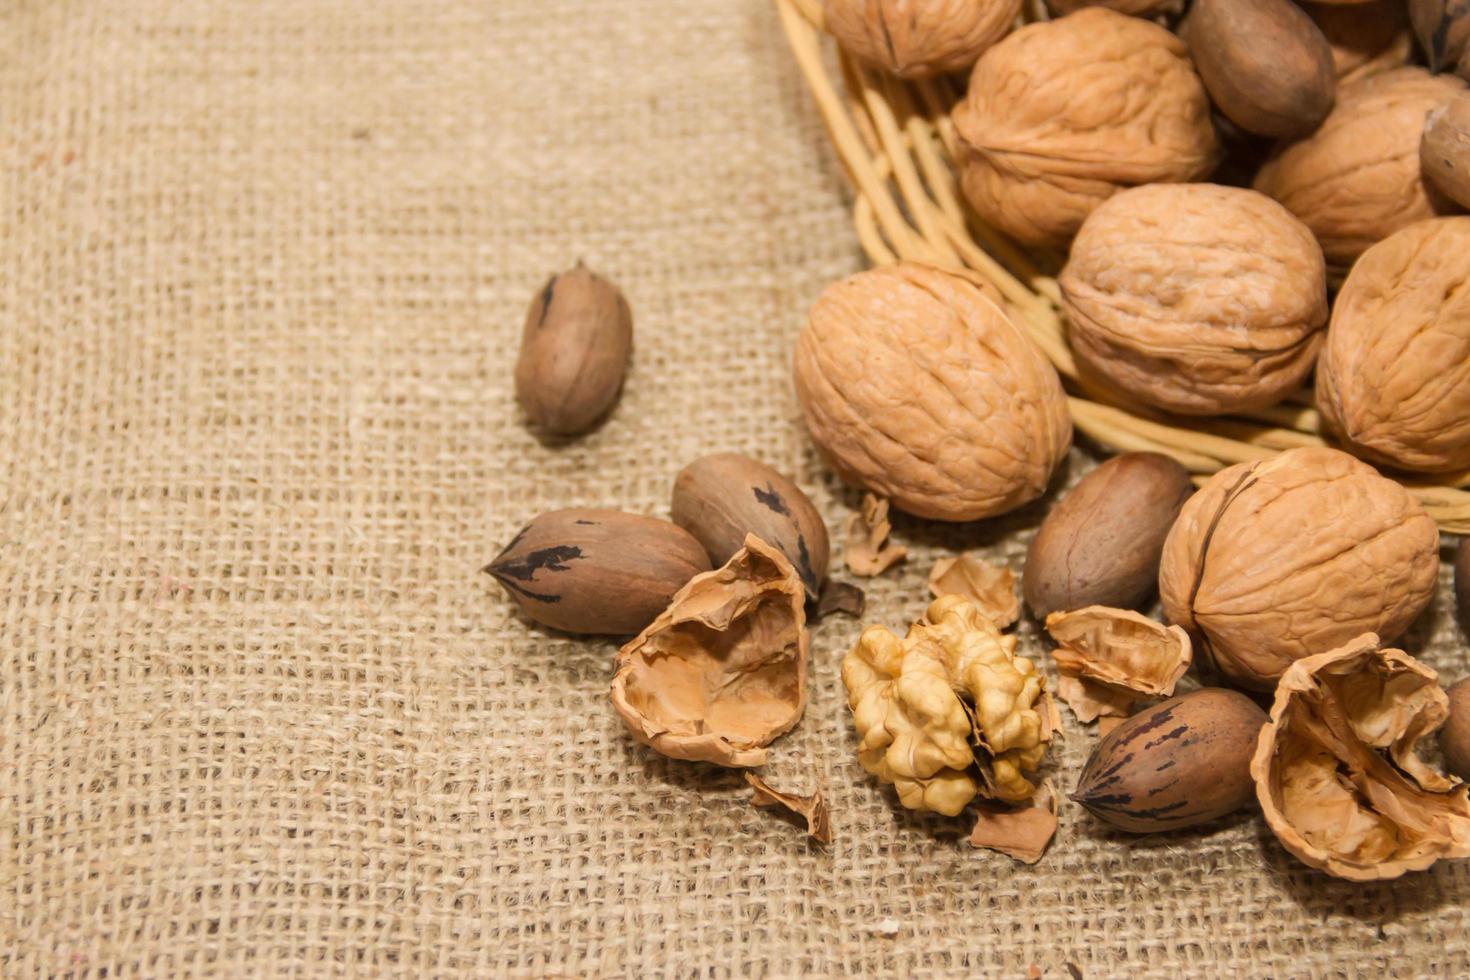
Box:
(1022, 453), (1194, 619)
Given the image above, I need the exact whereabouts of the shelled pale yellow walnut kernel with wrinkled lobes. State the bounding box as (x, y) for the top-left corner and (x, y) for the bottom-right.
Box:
(842, 595), (1054, 817)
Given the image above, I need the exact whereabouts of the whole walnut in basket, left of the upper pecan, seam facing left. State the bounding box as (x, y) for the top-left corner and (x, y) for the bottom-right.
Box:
(954, 7), (1219, 245)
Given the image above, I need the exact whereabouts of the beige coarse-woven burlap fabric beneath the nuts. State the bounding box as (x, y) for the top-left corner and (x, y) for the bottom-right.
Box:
(0, 0), (1470, 977)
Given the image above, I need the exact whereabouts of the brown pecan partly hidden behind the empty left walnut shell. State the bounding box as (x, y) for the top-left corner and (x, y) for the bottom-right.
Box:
(669, 453), (831, 599)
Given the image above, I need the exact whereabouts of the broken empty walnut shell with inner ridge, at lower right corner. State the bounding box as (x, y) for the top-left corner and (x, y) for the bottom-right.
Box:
(1251, 633), (1470, 882)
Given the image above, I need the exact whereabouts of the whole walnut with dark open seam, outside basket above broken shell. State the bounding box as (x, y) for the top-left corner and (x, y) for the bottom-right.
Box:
(1158, 448), (1439, 691)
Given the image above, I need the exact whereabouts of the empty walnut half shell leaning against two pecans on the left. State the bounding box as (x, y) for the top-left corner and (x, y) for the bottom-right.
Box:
(612, 535), (809, 767)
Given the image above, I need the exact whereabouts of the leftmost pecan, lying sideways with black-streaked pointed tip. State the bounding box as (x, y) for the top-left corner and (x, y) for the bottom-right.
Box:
(484, 507), (710, 635)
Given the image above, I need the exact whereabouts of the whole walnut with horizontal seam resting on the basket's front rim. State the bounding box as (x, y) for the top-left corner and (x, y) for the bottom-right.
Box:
(1060, 184), (1327, 414)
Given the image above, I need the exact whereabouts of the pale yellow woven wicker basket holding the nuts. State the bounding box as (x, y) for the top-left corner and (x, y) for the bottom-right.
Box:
(776, 0), (1470, 533)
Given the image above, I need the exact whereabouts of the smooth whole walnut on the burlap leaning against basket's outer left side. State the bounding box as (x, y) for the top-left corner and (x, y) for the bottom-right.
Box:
(795, 263), (1072, 520)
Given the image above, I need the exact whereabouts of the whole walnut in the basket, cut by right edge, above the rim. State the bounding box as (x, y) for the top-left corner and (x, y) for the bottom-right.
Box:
(1317, 217), (1470, 473)
